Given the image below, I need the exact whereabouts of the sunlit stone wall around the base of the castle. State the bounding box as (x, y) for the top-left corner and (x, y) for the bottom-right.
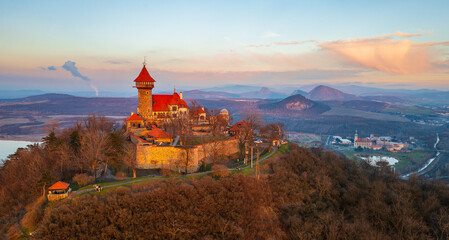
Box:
(137, 139), (239, 172)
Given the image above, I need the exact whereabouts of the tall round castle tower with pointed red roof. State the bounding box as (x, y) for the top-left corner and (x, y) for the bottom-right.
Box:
(134, 63), (156, 121)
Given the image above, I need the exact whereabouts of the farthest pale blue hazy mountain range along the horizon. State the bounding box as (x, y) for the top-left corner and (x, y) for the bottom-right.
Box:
(0, 85), (449, 104)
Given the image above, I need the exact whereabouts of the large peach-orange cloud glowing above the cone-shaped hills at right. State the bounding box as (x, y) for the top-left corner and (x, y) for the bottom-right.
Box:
(319, 32), (449, 74)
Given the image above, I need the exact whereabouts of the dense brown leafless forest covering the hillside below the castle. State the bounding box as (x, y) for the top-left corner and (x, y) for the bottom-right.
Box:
(4, 145), (449, 239)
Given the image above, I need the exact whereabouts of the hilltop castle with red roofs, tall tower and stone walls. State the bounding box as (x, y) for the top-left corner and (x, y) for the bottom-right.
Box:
(121, 63), (234, 172)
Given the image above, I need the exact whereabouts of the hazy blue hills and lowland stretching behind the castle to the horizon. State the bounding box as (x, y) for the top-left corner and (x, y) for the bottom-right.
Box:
(0, 86), (439, 142)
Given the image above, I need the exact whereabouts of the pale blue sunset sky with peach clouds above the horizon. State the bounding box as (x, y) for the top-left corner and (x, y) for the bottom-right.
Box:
(0, 0), (449, 95)
